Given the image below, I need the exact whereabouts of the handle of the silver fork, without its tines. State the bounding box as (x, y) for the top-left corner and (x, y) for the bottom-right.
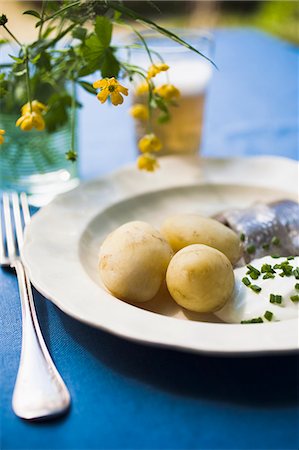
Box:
(12, 260), (70, 420)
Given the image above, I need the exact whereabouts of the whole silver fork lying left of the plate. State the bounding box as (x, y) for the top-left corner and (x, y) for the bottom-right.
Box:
(0, 192), (70, 420)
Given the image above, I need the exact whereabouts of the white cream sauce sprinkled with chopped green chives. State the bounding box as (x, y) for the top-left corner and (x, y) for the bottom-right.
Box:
(215, 256), (299, 323)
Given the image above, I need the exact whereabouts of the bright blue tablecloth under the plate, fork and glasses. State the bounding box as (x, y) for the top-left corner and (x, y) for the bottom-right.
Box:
(0, 29), (299, 449)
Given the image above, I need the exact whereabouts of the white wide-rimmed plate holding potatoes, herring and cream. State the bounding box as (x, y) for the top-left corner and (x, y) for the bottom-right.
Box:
(22, 157), (298, 354)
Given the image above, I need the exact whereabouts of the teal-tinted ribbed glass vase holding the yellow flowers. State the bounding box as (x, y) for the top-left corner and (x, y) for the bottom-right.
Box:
(0, 113), (78, 206)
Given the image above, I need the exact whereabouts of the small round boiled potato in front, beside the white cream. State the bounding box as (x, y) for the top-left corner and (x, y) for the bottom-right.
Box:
(166, 244), (234, 313)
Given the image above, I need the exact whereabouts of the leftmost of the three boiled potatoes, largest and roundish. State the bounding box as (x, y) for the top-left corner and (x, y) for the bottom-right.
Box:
(100, 221), (173, 302)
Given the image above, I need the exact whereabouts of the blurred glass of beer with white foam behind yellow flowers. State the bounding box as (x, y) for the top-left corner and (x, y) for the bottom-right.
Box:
(131, 30), (213, 155)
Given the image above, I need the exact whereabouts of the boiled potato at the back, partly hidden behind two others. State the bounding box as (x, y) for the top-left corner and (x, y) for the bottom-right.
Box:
(161, 214), (241, 264)
